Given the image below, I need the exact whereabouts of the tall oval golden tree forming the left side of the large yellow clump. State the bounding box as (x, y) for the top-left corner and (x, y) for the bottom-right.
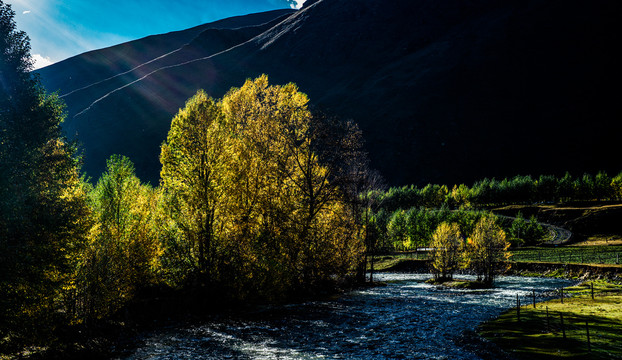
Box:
(160, 91), (231, 282)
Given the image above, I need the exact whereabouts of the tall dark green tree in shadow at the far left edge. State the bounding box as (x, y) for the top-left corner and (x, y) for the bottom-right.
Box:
(0, 1), (90, 341)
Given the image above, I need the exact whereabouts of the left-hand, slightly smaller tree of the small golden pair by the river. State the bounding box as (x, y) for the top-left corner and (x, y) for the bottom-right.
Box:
(430, 222), (462, 281)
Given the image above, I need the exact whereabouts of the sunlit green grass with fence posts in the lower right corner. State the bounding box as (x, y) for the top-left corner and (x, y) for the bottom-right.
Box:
(479, 281), (622, 360)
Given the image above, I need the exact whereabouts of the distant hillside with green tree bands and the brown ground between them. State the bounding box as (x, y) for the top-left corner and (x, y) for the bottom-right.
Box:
(364, 172), (622, 252)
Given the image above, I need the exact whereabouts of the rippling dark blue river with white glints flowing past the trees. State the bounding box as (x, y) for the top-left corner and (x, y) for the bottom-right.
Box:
(119, 274), (571, 360)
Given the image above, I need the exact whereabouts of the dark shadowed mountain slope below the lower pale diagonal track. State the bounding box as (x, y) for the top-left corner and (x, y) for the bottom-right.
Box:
(40, 0), (622, 184)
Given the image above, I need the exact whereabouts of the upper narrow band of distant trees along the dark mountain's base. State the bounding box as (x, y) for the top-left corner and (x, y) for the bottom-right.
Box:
(370, 172), (622, 211)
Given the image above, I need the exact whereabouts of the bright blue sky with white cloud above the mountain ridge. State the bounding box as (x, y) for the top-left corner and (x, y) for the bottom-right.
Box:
(4, 0), (304, 67)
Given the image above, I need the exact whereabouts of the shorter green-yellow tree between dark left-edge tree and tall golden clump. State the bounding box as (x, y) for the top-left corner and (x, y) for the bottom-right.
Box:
(77, 155), (161, 320)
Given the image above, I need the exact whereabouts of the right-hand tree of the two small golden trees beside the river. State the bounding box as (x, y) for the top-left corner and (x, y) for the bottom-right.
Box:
(464, 216), (510, 285)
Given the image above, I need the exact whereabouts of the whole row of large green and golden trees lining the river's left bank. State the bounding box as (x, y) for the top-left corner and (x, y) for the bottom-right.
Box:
(0, 2), (380, 350)
